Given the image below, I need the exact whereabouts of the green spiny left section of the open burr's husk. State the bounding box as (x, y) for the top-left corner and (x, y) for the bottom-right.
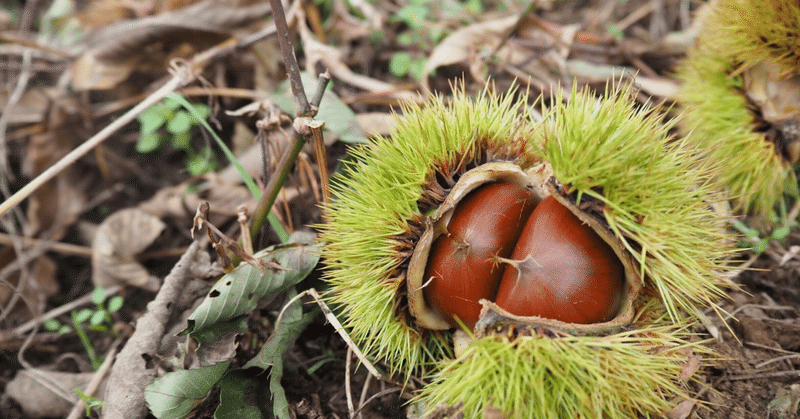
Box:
(320, 86), (536, 373)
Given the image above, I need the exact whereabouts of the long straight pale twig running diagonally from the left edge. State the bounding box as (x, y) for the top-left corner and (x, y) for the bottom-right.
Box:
(0, 24), (283, 215)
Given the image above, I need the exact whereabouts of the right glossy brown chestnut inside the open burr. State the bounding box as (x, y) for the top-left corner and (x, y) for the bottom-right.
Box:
(495, 196), (625, 324)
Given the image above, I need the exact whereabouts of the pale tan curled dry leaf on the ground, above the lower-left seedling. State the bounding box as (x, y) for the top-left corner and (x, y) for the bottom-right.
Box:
(92, 208), (166, 290)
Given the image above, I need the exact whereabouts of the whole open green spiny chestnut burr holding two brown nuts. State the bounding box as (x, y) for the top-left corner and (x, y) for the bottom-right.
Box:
(320, 83), (731, 419)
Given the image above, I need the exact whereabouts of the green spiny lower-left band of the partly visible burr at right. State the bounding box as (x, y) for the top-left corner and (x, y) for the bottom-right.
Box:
(678, 48), (797, 214)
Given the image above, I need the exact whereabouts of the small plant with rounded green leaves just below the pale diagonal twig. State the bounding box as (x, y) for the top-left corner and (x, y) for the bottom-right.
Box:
(136, 97), (218, 176)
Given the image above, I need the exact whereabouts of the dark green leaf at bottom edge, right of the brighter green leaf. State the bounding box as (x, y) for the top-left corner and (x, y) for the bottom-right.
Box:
(214, 370), (272, 419)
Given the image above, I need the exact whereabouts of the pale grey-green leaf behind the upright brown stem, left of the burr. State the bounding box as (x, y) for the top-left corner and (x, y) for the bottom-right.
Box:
(269, 72), (367, 144)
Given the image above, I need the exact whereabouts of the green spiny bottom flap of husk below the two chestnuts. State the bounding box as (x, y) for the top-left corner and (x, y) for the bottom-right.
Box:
(414, 308), (712, 419)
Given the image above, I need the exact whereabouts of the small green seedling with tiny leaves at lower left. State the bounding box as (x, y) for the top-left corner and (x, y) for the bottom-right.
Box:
(42, 287), (125, 369)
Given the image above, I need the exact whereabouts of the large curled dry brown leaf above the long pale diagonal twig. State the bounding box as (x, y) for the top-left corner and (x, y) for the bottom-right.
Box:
(72, 1), (271, 90)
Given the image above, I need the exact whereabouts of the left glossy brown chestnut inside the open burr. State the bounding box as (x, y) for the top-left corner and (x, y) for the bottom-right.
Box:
(423, 183), (536, 328)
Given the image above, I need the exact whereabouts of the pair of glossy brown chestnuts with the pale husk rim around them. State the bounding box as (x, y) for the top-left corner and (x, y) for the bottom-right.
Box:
(409, 163), (638, 330)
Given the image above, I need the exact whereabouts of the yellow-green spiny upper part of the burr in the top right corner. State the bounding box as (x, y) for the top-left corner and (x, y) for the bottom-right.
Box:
(701, 0), (800, 74)
